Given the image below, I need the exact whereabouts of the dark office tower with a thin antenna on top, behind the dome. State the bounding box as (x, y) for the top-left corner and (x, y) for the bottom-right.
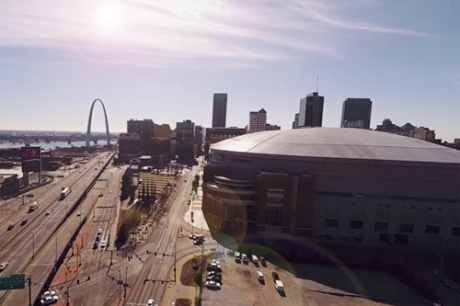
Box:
(299, 92), (324, 128)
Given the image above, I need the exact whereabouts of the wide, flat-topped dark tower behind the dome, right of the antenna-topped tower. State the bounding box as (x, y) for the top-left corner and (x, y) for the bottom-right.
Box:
(340, 98), (372, 129)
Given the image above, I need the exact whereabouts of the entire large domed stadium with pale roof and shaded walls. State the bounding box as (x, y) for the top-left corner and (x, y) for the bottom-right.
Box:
(202, 128), (460, 249)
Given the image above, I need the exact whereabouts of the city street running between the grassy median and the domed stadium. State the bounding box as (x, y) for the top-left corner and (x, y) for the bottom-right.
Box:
(127, 167), (199, 305)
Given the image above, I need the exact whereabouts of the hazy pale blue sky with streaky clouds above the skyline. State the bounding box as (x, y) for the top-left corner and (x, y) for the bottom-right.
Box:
(0, 0), (460, 141)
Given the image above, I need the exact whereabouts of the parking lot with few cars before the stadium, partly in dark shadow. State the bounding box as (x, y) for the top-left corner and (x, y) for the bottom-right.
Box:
(202, 251), (432, 306)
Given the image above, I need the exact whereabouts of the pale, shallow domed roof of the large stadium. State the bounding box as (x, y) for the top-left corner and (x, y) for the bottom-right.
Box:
(211, 128), (460, 165)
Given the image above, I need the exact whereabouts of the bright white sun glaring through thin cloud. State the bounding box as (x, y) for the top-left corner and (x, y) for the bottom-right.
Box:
(92, 0), (125, 38)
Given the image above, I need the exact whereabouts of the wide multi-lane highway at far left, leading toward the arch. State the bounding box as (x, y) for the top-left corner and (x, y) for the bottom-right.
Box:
(0, 153), (114, 305)
